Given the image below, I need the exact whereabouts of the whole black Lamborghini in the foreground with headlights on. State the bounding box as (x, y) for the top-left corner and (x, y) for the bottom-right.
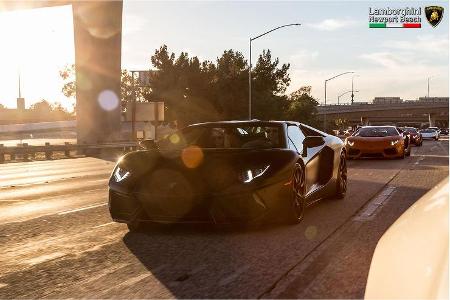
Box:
(109, 121), (347, 230)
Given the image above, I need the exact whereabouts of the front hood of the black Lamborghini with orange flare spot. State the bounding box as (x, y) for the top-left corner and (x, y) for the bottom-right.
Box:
(110, 147), (297, 191)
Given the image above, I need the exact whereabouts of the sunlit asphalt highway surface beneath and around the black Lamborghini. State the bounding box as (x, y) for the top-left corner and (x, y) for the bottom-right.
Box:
(0, 139), (449, 298)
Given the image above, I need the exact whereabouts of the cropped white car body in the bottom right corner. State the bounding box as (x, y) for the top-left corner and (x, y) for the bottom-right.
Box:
(365, 178), (449, 299)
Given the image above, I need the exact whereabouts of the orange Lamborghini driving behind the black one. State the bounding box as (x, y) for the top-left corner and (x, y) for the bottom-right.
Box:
(345, 126), (411, 158)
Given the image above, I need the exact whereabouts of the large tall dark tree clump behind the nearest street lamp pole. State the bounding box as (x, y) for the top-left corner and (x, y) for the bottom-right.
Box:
(149, 45), (290, 123)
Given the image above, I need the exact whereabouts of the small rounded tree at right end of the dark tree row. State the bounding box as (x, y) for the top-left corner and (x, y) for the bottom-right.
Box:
(288, 86), (319, 126)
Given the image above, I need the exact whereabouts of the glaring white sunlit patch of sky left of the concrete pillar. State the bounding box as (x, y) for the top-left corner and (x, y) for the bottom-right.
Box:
(0, 5), (75, 110)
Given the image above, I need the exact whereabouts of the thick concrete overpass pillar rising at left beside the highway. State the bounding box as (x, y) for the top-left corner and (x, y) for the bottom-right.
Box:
(72, 1), (123, 144)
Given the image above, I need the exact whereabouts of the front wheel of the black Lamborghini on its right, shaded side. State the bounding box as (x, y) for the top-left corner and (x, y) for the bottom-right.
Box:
(286, 163), (306, 224)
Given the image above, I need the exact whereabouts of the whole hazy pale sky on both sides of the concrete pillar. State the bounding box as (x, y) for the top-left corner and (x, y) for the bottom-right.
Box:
(0, 1), (449, 107)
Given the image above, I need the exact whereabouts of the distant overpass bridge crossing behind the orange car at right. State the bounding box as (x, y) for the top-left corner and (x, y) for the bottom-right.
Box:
(317, 97), (449, 128)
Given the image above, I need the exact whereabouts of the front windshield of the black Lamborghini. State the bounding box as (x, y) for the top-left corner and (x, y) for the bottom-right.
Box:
(158, 124), (283, 149)
